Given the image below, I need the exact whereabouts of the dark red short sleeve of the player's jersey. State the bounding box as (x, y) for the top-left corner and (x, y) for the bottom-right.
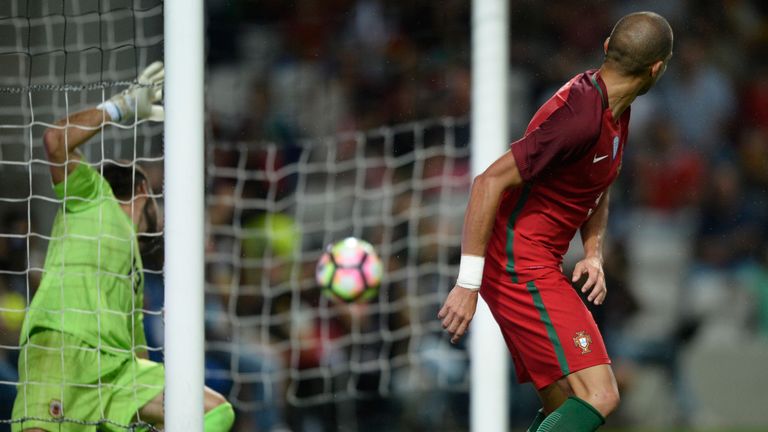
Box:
(511, 101), (602, 181)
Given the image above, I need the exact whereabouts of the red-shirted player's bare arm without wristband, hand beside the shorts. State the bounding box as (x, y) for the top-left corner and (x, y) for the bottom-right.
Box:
(571, 187), (610, 305)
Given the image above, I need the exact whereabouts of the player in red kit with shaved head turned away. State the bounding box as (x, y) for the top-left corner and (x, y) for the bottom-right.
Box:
(438, 12), (673, 432)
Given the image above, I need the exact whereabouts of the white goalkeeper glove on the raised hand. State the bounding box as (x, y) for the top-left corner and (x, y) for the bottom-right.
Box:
(98, 61), (165, 124)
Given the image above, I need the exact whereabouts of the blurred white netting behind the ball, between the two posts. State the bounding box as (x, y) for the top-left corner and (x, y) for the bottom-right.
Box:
(206, 118), (470, 424)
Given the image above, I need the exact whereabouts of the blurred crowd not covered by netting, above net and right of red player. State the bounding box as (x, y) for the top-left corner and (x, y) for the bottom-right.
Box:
(201, 0), (768, 426)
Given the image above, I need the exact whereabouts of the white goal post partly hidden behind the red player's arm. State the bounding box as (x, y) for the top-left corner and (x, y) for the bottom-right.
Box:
(470, 0), (509, 432)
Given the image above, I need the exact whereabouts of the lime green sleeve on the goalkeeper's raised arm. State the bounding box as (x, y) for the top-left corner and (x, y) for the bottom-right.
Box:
(53, 163), (109, 212)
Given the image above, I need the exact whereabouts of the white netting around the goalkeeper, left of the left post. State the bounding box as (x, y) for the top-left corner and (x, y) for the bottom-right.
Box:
(0, 0), (163, 428)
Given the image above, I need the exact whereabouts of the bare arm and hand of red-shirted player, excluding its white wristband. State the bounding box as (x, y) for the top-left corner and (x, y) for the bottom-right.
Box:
(437, 151), (523, 343)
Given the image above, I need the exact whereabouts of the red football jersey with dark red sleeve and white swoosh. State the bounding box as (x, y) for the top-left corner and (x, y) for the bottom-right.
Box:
(486, 70), (630, 282)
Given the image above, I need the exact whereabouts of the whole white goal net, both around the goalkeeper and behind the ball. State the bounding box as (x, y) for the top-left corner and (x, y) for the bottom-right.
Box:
(0, 0), (470, 430)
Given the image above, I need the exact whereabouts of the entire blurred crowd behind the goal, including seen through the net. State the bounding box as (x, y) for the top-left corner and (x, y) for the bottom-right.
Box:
(0, 0), (768, 431)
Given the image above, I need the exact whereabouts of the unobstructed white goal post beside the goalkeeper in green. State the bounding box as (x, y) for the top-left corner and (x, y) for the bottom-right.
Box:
(164, 0), (205, 432)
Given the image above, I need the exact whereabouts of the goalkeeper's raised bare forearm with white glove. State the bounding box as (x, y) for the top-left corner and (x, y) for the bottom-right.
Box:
(43, 62), (164, 184)
